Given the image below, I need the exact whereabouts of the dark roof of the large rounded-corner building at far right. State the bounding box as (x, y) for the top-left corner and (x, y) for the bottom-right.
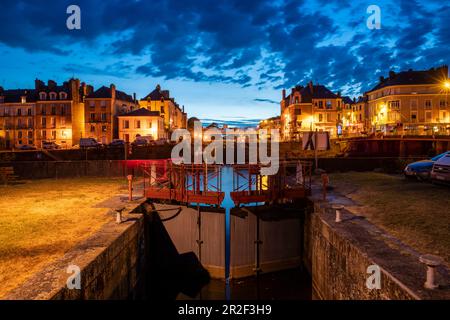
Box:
(368, 66), (448, 92)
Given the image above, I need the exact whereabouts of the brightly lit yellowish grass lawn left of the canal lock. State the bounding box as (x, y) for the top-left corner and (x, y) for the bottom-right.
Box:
(0, 178), (126, 298)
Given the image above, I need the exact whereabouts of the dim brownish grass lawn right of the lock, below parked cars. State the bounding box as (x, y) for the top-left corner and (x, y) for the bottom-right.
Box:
(330, 172), (450, 265)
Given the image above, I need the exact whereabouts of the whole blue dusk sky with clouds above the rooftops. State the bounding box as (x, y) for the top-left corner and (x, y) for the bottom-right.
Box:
(0, 0), (450, 125)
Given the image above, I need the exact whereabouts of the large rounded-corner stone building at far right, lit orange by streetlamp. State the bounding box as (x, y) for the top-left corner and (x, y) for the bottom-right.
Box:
(366, 66), (450, 135)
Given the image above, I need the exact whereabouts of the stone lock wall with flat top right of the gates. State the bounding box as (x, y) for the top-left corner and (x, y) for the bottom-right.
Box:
(304, 201), (450, 300)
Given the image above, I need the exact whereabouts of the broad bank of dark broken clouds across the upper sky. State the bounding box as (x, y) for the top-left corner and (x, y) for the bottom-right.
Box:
(0, 0), (450, 94)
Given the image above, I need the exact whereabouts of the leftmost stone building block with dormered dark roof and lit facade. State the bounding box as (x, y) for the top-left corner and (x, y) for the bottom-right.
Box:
(0, 79), (85, 149)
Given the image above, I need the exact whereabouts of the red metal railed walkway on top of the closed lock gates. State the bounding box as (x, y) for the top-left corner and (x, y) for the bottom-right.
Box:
(140, 159), (312, 207)
